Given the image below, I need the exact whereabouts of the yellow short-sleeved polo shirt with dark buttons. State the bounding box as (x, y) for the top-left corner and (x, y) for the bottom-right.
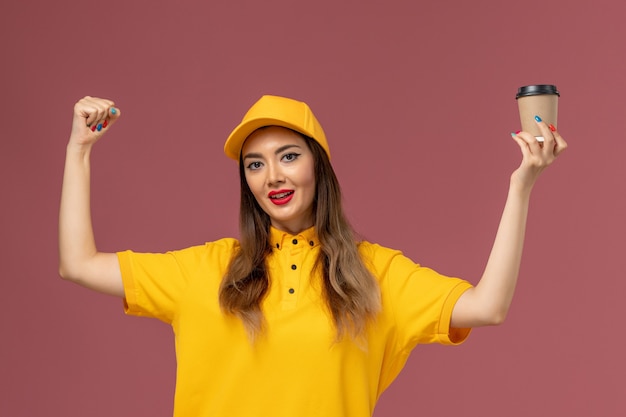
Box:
(118, 228), (470, 417)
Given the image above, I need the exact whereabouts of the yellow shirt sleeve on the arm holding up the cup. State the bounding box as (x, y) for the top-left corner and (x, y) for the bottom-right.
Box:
(364, 245), (472, 350)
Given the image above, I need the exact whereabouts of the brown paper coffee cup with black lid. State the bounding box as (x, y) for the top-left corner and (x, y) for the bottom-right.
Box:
(515, 84), (560, 142)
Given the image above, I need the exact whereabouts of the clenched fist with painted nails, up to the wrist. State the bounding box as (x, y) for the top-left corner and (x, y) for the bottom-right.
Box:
(69, 96), (121, 146)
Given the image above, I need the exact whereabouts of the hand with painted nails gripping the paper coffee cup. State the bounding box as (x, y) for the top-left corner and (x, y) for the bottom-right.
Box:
(511, 117), (567, 190)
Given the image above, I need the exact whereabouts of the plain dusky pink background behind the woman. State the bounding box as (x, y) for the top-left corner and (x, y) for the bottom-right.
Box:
(0, 0), (626, 417)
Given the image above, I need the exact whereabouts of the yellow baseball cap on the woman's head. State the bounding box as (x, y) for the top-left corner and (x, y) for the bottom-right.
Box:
(224, 96), (330, 161)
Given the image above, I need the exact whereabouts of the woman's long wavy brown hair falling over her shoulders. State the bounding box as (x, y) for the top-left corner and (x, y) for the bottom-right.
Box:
(219, 133), (380, 340)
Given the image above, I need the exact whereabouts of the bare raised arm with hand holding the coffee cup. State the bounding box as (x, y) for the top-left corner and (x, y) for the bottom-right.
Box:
(451, 120), (567, 328)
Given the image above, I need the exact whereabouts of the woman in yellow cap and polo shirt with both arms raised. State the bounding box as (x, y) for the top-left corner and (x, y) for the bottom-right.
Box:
(60, 96), (567, 417)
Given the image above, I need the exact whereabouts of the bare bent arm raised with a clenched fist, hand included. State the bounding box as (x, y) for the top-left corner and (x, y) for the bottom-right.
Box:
(59, 97), (124, 297)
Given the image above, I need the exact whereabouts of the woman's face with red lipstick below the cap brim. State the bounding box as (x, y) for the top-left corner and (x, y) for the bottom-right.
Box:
(241, 126), (315, 234)
